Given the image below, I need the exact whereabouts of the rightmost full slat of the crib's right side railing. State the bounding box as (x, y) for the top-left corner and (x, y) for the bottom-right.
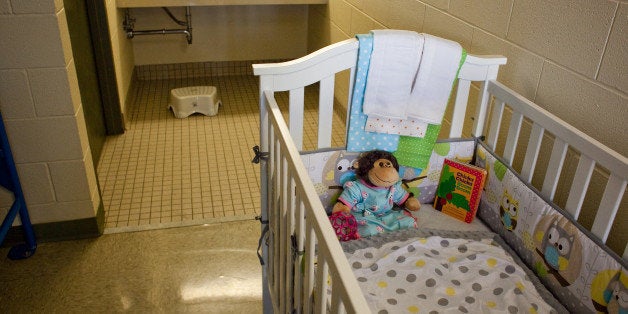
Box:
(591, 174), (626, 243)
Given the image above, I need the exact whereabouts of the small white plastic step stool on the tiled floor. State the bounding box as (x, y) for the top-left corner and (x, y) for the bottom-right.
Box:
(168, 86), (222, 118)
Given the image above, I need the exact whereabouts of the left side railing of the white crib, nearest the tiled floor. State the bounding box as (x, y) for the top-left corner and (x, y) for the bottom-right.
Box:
(263, 92), (369, 313)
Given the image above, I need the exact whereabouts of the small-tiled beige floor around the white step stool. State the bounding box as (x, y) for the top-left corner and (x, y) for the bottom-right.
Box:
(98, 76), (344, 233)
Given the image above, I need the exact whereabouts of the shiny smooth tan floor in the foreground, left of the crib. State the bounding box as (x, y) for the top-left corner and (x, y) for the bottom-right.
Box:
(0, 220), (262, 314)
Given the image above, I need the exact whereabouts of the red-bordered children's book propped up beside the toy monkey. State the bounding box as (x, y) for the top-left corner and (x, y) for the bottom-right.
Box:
(434, 159), (487, 223)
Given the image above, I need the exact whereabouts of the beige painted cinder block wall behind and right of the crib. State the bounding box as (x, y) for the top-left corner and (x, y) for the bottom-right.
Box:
(308, 0), (628, 253)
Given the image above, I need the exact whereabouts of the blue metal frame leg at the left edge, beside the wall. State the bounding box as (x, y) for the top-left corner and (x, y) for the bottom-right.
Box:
(0, 113), (37, 260)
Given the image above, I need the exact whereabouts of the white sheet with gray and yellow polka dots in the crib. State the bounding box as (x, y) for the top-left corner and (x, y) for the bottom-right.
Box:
(343, 230), (566, 313)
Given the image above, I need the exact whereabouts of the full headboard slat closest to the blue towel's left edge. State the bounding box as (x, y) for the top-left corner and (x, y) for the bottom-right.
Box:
(318, 75), (335, 149)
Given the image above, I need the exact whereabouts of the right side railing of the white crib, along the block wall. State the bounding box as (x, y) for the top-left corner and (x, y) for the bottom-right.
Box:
(486, 81), (628, 260)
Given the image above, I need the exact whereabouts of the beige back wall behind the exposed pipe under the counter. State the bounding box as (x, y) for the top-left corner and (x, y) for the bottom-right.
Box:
(124, 5), (308, 65)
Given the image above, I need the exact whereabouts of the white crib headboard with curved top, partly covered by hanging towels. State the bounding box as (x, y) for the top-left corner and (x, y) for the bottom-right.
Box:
(253, 38), (506, 150)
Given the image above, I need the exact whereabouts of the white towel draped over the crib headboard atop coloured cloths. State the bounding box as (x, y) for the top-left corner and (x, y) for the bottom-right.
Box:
(363, 30), (462, 137)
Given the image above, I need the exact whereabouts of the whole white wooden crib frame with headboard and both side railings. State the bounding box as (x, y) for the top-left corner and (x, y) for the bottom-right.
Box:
(253, 39), (628, 313)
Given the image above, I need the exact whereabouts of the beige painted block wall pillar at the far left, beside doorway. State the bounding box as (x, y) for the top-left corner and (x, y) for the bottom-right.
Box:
(0, 0), (100, 224)
